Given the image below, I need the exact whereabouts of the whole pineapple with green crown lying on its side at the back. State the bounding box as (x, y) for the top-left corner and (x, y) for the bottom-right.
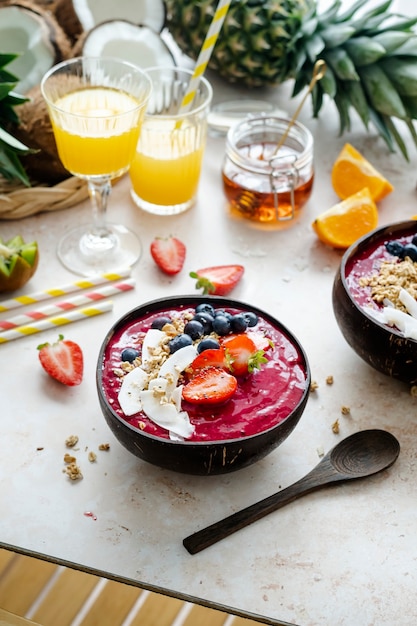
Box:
(165, 0), (417, 158)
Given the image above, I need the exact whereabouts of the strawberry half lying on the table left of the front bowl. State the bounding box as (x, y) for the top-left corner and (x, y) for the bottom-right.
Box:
(38, 335), (84, 387)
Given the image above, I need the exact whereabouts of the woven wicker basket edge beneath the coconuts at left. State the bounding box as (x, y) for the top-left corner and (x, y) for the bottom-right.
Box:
(0, 176), (88, 220)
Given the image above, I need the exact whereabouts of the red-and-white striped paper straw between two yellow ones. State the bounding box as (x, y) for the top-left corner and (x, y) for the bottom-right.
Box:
(0, 278), (135, 333)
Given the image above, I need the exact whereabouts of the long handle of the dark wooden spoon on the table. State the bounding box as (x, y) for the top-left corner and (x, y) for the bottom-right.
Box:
(183, 463), (342, 554)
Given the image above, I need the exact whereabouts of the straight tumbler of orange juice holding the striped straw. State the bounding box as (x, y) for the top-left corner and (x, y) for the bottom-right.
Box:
(129, 67), (213, 215)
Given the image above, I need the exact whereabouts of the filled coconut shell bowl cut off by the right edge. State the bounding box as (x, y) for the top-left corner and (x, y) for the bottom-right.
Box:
(332, 220), (417, 385)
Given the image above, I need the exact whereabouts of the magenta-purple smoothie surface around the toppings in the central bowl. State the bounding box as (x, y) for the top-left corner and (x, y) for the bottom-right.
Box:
(102, 306), (307, 441)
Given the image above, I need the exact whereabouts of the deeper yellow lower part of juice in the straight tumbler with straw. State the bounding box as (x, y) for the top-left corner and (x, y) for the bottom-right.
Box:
(129, 146), (204, 206)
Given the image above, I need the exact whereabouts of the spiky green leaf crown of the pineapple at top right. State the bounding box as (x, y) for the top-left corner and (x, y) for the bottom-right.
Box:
(292, 0), (417, 158)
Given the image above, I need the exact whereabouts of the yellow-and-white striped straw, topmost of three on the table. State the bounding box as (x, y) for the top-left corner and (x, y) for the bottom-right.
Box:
(0, 269), (131, 313)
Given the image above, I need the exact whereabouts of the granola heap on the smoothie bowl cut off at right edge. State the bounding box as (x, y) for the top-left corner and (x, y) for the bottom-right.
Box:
(359, 257), (417, 311)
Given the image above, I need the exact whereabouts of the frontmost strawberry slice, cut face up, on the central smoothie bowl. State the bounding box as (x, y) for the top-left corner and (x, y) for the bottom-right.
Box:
(182, 367), (237, 404)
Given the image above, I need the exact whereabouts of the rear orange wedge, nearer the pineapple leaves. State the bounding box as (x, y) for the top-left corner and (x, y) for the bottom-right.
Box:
(332, 143), (394, 202)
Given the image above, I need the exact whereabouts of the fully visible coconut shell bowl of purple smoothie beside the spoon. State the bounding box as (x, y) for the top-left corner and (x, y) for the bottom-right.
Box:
(97, 296), (311, 475)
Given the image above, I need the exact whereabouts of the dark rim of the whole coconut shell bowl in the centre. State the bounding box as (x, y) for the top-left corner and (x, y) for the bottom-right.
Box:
(96, 294), (311, 448)
